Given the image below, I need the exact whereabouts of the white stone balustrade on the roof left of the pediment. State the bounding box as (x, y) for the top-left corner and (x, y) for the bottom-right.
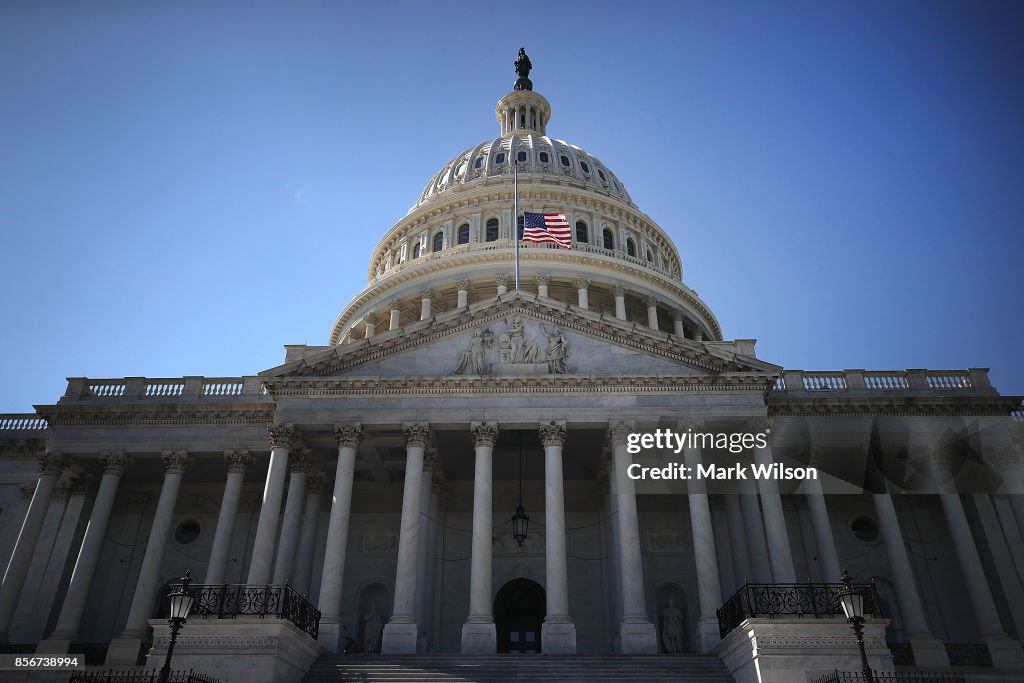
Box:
(60, 376), (266, 402)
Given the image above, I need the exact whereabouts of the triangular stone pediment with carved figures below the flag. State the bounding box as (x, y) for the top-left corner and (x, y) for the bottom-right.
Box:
(260, 292), (781, 388)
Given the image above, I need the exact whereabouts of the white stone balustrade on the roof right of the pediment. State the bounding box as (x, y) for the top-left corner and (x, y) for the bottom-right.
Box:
(774, 368), (994, 394)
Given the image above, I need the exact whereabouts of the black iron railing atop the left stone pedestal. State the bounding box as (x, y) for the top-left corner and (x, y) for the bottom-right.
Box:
(160, 584), (321, 638)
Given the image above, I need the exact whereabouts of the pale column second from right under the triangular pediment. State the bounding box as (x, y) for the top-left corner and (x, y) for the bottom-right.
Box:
(679, 420), (722, 652)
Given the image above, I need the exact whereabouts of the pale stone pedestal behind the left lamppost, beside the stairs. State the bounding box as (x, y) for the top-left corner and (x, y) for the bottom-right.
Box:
(145, 616), (326, 683)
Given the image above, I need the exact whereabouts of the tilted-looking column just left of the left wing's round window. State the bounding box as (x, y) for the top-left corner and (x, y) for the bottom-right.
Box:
(122, 451), (191, 637)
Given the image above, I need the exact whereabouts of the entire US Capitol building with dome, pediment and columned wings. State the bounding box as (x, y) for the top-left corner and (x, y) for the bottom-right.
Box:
(0, 52), (1024, 683)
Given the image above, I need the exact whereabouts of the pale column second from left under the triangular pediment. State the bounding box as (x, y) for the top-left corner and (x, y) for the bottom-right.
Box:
(317, 422), (362, 652)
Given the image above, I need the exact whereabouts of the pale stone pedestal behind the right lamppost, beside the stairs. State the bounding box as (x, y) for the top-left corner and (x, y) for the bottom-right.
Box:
(712, 616), (896, 683)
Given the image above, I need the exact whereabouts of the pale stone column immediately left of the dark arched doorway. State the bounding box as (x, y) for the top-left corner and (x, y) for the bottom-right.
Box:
(462, 422), (498, 654)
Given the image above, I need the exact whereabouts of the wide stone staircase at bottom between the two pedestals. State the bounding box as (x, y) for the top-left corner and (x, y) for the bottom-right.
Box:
(304, 654), (733, 683)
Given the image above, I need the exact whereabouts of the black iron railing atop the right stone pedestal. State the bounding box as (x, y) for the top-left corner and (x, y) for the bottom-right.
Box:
(718, 584), (882, 638)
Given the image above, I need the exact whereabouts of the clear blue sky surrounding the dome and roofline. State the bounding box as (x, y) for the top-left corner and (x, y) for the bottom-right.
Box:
(0, 1), (1024, 412)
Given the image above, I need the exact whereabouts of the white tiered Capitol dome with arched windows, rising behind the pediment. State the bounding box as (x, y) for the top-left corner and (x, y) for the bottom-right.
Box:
(330, 55), (722, 344)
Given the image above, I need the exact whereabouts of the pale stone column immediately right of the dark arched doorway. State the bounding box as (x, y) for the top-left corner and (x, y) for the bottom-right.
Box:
(540, 420), (575, 654)
